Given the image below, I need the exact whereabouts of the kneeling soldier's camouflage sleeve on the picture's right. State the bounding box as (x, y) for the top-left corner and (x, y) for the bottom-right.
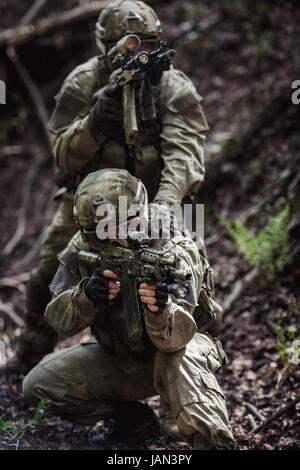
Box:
(144, 239), (203, 352)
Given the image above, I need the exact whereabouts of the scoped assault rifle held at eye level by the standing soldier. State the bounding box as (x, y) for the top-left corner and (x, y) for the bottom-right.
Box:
(107, 34), (176, 145)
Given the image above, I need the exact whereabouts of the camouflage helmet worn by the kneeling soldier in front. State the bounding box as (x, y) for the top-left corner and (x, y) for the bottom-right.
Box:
(73, 168), (148, 242)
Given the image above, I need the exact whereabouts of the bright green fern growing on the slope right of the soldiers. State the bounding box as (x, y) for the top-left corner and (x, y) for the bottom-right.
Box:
(218, 204), (290, 278)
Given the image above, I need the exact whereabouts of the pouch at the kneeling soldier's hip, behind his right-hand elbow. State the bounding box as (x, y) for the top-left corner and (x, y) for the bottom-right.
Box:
(193, 255), (223, 337)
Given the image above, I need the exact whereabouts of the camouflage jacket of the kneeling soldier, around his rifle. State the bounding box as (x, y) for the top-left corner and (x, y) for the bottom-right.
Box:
(45, 232), (203, 357)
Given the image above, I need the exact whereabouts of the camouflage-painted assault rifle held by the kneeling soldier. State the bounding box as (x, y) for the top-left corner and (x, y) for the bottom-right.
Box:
(79, 245), (194, 340)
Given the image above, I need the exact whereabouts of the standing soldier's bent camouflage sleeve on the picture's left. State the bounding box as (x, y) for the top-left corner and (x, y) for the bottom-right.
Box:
(48, 61), (105, 174)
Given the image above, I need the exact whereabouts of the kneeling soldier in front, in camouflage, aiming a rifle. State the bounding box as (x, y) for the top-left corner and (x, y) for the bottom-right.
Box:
(24, 169), (235, 450)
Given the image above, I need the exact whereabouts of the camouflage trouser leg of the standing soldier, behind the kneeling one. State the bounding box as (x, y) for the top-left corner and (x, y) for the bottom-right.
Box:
(16, 194), (78, 370)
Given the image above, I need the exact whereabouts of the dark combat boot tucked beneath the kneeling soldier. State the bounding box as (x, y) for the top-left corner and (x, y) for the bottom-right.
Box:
(90, 401), (159, 448)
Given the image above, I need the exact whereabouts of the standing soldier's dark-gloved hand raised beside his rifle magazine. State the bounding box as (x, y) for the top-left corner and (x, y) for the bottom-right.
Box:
(89, 85), (124, 141)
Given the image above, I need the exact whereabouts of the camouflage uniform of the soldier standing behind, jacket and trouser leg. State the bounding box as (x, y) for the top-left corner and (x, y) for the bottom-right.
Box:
(17, 44), (208, 365)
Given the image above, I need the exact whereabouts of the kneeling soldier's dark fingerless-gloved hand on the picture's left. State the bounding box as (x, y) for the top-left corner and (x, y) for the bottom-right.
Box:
(83, 269), (120, 307)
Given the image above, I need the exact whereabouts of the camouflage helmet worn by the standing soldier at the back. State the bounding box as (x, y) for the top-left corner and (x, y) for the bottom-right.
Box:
(95, 0), (162, 50)
